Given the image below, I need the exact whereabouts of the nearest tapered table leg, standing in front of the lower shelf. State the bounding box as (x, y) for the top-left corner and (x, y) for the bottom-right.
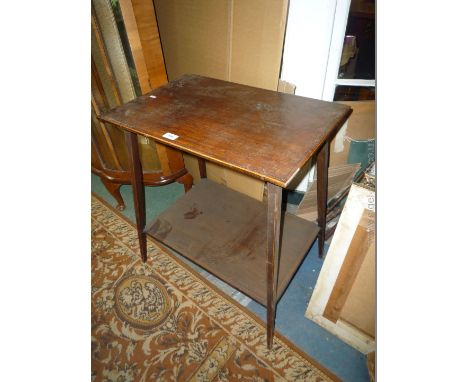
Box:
(266, 183), (282, 349)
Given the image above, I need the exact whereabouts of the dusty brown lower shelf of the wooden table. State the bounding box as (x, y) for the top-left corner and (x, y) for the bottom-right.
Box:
(145, 179), (319, 306)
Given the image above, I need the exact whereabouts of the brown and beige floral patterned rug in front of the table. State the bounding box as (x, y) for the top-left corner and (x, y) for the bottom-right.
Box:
(91, 196), (338, 382)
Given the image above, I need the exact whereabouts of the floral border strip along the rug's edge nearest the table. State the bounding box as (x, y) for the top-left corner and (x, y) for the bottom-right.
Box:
(91, 193), (340, 381)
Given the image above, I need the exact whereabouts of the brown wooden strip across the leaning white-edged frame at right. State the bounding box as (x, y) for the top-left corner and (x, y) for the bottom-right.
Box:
(323, 210), (370, 322)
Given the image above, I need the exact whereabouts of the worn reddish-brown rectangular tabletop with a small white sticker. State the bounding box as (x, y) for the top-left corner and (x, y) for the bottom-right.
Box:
(101, 75), (351, 187)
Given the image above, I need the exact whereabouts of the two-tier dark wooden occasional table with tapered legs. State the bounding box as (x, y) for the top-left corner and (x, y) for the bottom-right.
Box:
(100, 75), (352, 348)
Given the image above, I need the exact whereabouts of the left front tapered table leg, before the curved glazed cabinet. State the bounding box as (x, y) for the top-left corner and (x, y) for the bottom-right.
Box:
(125, 131), (147, 262)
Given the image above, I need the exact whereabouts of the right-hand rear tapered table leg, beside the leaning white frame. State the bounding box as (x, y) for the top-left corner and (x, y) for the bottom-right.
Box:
(317, 141), (330, 258)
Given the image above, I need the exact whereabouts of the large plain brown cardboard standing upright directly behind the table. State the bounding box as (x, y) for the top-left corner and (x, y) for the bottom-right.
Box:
(154, 0), (288, 200)
